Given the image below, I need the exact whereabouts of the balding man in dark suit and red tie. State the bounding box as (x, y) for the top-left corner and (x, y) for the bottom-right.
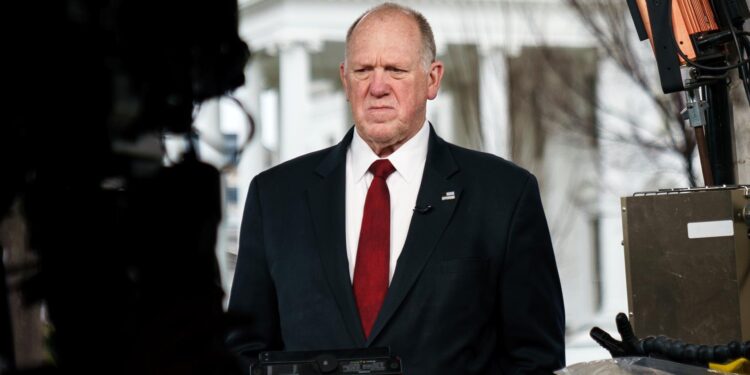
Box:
(228, 4), (564, 375)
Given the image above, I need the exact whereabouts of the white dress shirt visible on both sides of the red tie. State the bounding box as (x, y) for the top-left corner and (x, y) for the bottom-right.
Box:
(346, 121), (430, 283)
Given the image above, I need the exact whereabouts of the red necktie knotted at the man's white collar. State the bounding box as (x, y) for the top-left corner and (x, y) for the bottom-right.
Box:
(353, 159), (396, 337)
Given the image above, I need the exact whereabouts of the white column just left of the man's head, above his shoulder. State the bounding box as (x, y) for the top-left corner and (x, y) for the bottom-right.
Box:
(279, 42), (311, 162)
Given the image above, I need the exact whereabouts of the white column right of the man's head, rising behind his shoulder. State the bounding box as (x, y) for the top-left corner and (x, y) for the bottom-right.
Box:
(479, 46), (510, 159)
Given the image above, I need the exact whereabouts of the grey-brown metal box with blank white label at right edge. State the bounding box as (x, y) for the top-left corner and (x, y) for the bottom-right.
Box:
(621, 186), (750, 345)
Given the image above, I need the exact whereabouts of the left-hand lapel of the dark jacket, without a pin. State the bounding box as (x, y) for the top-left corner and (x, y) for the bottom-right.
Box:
(307, 130), (365, 347)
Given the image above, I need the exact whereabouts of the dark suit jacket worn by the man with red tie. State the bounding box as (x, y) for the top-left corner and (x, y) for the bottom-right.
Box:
(228, 125), (565, 375)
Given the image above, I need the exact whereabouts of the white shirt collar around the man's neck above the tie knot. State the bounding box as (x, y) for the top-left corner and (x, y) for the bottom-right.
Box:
(350, 121), (430, 183)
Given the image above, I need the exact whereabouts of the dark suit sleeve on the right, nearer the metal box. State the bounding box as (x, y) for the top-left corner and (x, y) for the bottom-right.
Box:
(498, 174), (565, 374)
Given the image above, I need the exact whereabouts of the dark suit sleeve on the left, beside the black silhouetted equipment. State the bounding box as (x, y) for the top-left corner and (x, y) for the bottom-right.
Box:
(227, 177), (283, 370)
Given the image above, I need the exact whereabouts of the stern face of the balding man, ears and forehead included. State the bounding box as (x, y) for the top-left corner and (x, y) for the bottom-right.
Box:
(340, 11), (443, 156)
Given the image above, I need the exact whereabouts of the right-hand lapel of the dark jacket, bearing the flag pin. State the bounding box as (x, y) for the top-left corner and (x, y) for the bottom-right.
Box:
(367, 127), (461, 346)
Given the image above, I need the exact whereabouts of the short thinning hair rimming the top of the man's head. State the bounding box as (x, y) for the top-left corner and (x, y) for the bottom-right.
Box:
(344, 3), (436, 69)
